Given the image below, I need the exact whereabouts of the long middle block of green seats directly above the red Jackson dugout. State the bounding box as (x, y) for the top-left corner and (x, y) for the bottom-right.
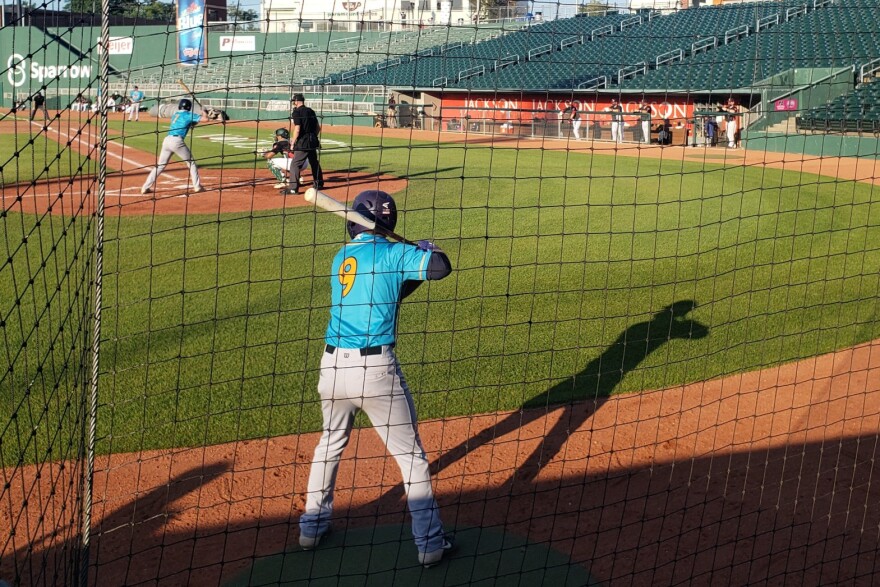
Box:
(336, 2), (791, 90)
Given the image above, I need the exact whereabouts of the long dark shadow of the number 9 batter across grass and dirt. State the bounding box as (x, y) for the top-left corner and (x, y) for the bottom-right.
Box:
(432, 300), (709, 480)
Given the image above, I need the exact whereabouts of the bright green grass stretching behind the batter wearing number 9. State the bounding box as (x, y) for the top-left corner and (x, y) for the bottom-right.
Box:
(0, 131), (880, 465)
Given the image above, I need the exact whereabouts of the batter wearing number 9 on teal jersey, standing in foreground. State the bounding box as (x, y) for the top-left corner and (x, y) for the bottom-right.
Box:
(300, 191), (452, 567)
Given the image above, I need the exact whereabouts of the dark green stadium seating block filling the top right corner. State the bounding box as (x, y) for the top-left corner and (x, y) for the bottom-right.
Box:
(620, 0), (880, 91)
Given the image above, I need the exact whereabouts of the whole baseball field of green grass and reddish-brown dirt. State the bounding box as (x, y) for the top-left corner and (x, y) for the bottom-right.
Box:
(0, 111), (880, 585)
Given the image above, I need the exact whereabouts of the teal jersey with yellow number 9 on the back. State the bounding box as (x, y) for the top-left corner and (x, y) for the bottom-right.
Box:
(324, 232), (431, 349)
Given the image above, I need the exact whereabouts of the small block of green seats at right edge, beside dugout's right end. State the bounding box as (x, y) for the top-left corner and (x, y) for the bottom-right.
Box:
(797, 80), (880, 133)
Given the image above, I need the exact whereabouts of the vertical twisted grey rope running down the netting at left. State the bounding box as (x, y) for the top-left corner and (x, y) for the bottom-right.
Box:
(80, 0), (110, 587)
